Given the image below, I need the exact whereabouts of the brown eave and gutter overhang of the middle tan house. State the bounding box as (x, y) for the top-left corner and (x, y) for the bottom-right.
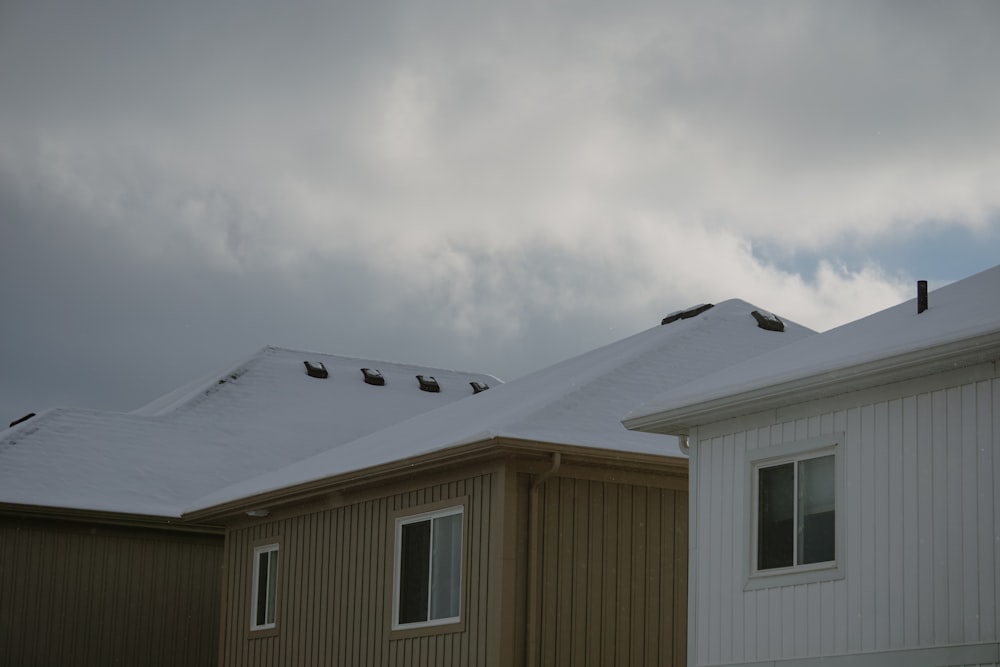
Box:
(183, 437), (688, 522)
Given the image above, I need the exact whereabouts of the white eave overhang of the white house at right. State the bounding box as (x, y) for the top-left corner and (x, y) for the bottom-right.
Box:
(623, 331), (1000, 435)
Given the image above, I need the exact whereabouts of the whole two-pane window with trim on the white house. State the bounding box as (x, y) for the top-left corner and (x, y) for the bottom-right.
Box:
(748, 439), (843, 588)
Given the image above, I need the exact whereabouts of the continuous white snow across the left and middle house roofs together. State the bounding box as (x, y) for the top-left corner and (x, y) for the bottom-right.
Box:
(0, 300), (812, 518)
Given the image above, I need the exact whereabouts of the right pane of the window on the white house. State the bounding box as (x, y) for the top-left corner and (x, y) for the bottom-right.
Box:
(798, 455), (836, 565)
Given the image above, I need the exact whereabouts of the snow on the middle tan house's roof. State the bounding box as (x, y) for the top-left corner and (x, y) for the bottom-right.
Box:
(189, 299), (813, 511)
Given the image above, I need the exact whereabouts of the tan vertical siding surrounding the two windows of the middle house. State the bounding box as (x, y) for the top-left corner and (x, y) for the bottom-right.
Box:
(222, 475), (495, 667)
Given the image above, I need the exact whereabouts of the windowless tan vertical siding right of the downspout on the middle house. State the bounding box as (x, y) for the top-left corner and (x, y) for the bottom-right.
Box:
(537, 477), (687, 667)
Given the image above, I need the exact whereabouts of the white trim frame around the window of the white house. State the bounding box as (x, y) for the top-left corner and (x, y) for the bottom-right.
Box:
(744, 433), (845, 590)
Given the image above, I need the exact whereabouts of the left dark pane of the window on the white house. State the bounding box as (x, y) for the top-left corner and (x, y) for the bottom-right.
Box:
(757, 463), (795, 570)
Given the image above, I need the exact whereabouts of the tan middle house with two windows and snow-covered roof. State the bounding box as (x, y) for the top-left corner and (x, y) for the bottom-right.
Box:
(184, 301), (811, 667)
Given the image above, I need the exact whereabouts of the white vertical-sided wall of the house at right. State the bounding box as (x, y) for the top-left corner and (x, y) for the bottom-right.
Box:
(690, 364), (1000, 665)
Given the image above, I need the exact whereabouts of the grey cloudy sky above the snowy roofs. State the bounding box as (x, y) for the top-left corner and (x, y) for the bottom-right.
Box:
(0, 0), (1000, 425)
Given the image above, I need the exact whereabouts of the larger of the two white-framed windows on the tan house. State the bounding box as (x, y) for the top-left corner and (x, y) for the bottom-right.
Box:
(392, 505), (465, 629)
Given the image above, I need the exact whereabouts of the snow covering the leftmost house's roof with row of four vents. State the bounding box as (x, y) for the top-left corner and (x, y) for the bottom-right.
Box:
(0, 347), (502, 517)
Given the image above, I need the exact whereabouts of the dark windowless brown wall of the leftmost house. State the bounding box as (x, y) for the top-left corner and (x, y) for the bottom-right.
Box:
(0, 516), (222, 667)
